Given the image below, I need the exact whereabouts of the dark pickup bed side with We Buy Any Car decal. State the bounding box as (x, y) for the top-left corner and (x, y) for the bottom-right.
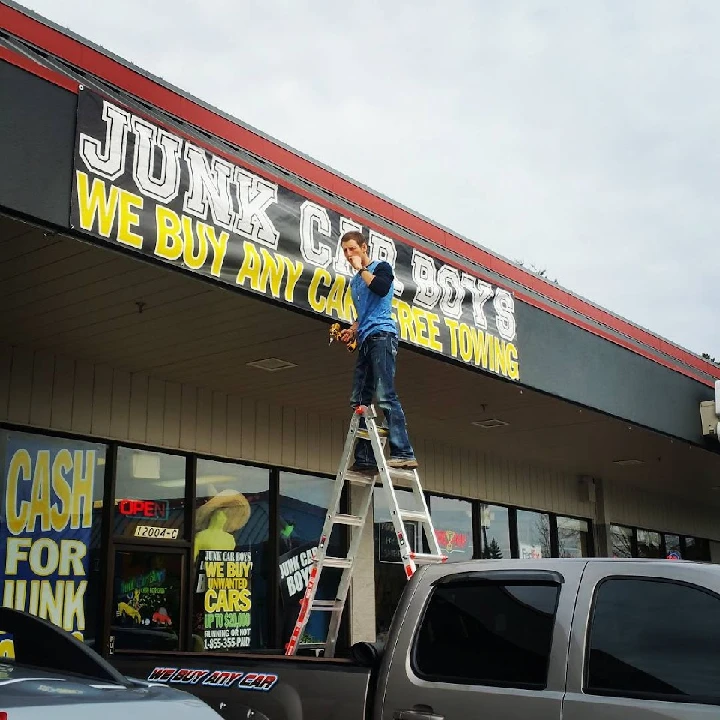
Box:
(110, 652), (370, 720)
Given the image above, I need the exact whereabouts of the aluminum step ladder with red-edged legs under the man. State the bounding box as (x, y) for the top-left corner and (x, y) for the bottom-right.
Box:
(285, 405), (447, 657)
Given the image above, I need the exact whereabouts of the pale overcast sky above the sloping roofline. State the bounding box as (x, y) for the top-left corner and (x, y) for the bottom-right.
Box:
(15, 0), (720, 359)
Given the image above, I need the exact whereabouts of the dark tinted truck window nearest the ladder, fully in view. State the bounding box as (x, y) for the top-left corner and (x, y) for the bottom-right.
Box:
(412, 579), (560, 690)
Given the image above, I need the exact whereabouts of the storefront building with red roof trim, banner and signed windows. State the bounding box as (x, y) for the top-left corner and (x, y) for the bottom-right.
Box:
(0, 3), (720, 655)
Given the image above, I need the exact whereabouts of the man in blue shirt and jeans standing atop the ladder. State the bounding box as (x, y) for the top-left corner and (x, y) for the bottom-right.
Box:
(340, 230), (418, 475)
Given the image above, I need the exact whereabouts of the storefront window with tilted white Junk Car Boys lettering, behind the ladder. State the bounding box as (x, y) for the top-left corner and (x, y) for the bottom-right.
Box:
(278, 472), (345, 645)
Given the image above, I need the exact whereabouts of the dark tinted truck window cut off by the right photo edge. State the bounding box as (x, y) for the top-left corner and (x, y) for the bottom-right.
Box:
(585, 578), (720, 704)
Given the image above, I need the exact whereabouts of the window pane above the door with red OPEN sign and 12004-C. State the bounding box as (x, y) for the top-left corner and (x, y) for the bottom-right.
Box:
(114, 447), (186, 540)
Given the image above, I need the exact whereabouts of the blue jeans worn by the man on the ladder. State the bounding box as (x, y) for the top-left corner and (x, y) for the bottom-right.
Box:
(350, 332), (415, 467)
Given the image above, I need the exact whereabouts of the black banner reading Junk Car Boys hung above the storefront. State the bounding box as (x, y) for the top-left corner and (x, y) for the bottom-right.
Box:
(71, 90), (520, 380)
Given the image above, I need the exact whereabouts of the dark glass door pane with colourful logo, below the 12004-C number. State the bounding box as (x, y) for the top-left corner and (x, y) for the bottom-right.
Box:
(110, 550), (184, 651)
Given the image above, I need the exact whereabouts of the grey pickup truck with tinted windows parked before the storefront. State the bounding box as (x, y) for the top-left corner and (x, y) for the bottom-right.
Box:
(112, 558), (720, 720)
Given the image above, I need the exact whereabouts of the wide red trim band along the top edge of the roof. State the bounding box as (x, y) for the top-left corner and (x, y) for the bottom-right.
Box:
(2, 5), (720, 382)
